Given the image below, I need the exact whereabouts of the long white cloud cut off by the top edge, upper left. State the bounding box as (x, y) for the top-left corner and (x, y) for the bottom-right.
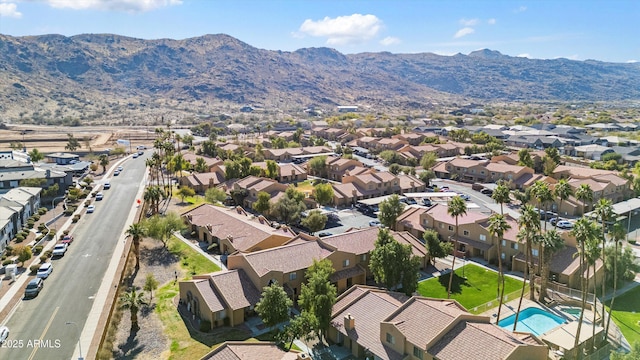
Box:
(44, 0), (182, 12)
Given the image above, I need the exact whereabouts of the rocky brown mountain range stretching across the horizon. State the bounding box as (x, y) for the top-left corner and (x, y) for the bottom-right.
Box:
(0, 34), (640, 120)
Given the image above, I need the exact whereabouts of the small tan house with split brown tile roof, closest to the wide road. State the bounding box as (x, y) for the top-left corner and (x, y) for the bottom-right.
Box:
(179, 270), (261, 328)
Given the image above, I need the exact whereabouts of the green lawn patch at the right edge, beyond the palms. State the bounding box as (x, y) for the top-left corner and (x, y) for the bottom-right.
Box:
(606, 287), (640, 344)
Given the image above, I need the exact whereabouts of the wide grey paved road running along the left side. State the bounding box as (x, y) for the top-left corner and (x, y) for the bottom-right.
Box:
(0, 158), (145, 360)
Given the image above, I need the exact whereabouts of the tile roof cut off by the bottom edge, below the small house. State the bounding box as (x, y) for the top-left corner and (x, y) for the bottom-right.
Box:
(201, 341), (299, 360)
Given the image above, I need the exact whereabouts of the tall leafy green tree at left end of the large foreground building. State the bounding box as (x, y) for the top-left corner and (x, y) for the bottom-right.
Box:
(298, 259), (338, 340)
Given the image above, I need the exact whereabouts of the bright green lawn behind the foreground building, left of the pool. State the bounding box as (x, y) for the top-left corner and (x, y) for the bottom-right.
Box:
(418, 264), (522, 309)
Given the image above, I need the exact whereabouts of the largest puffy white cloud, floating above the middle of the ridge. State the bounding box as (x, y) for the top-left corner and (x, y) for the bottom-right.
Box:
(298, 14), (383, 45)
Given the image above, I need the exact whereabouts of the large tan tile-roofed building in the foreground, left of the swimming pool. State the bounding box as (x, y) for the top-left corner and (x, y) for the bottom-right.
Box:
(328, 286), (548, 360)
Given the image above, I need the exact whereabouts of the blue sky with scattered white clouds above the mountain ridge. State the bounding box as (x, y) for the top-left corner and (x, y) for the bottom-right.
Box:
(0, 0), (640, 62)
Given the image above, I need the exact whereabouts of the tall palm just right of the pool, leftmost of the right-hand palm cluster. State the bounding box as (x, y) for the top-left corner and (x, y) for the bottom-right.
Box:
(571, 217), (597, 348)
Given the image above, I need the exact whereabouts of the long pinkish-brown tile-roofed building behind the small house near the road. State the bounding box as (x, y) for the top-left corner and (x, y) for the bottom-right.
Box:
(182, 204), (296, 254)
